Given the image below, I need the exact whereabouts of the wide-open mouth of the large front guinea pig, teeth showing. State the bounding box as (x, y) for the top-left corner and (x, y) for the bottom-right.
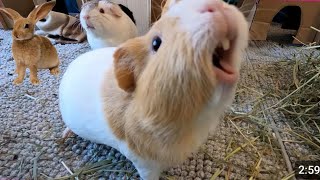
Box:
(212, 39), (238, 83)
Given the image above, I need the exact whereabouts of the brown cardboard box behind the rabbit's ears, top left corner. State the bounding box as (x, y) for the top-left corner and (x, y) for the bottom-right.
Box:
(0, 0), (34, 29)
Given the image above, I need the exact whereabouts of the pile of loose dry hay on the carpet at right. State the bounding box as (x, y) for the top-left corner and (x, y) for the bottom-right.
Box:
(217, 28), (320, 179)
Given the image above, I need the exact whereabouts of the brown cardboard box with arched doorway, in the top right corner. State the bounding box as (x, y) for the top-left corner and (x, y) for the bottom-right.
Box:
(240, 0), (320, 44)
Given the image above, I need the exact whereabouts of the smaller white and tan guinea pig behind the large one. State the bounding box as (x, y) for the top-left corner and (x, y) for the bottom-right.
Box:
(80, 0), (138, 49)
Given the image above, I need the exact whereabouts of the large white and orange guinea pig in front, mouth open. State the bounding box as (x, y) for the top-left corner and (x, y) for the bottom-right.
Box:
(59, 0), (248, 180)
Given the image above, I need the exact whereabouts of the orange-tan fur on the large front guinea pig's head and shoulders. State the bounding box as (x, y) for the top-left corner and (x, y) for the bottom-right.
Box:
(103, 18), (216, 164)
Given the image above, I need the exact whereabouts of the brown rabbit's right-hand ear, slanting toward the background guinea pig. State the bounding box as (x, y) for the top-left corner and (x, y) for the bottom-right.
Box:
(28, 1), (56, 23)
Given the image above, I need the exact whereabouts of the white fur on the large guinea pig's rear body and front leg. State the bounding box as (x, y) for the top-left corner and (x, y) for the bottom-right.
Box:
(59, 48), (162, 179)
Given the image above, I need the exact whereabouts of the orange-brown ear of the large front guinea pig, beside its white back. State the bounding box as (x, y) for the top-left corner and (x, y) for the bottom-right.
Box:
(113, 47), (135, 92)
